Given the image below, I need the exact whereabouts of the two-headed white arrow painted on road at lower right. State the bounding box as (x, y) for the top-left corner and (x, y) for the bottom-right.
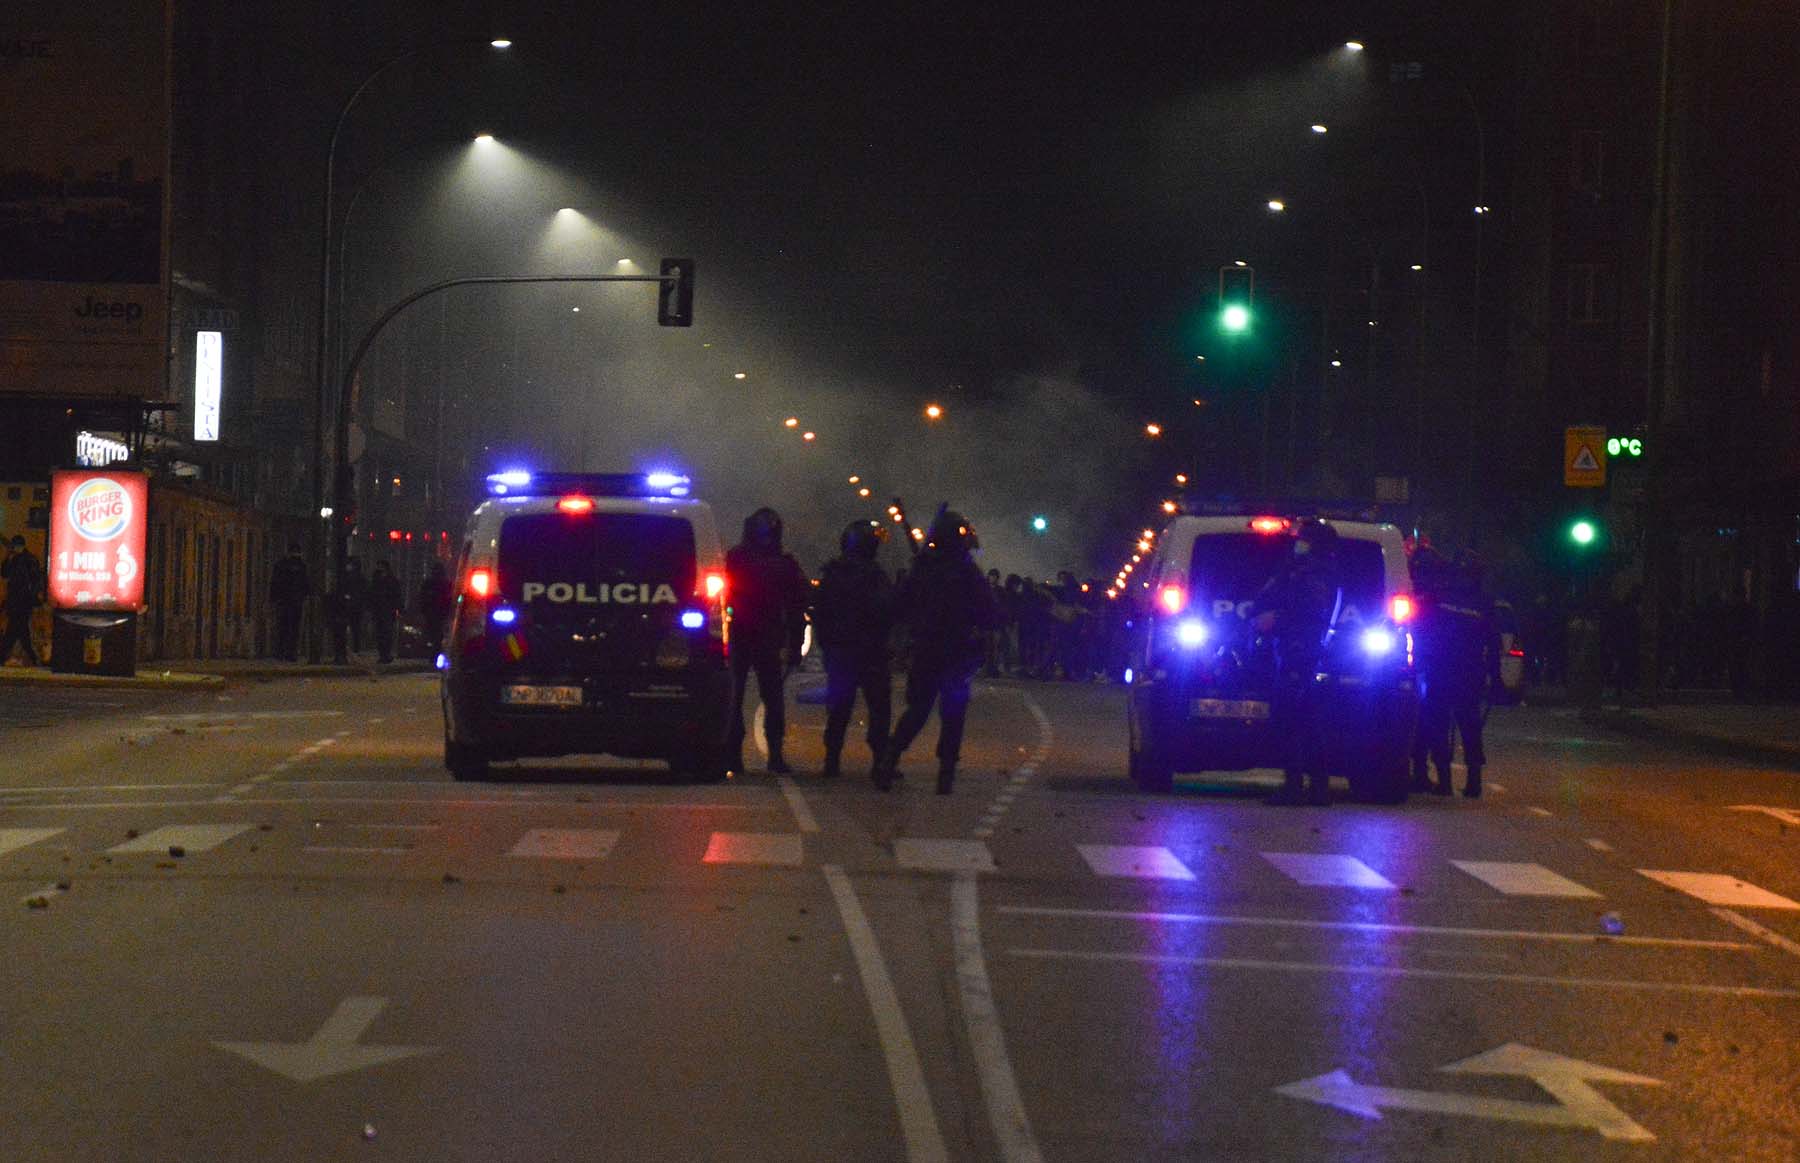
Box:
(1274, 1042), (1661, 1143)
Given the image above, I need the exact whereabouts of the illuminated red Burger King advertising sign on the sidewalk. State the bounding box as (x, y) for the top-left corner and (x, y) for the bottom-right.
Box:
(47, 470), (149, 610)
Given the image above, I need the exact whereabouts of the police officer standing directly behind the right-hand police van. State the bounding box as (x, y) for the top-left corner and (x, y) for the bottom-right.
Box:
(1249, 518), (1341, 805)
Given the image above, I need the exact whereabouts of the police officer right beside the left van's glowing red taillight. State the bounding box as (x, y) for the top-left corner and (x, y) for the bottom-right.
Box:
(725, 508), (812, 776)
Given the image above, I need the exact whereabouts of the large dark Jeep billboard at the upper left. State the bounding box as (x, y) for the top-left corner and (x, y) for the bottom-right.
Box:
(0, 0), (169, 398)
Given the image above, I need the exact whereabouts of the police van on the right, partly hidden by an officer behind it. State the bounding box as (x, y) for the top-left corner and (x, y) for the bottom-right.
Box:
(1127, 509), (1418, 803)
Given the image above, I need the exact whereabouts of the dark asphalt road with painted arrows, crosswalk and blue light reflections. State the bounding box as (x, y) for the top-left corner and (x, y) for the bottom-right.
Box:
(0, 675), (1800, 1163)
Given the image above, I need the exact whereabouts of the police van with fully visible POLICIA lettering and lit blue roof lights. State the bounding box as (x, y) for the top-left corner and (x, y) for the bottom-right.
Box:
(437, 472), (731, 780)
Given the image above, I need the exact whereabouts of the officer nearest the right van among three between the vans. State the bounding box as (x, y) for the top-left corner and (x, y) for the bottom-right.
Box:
(873, 509), (995, 796)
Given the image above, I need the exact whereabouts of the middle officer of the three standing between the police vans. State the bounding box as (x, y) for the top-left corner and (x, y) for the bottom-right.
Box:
(812, 520), (895, 778)
